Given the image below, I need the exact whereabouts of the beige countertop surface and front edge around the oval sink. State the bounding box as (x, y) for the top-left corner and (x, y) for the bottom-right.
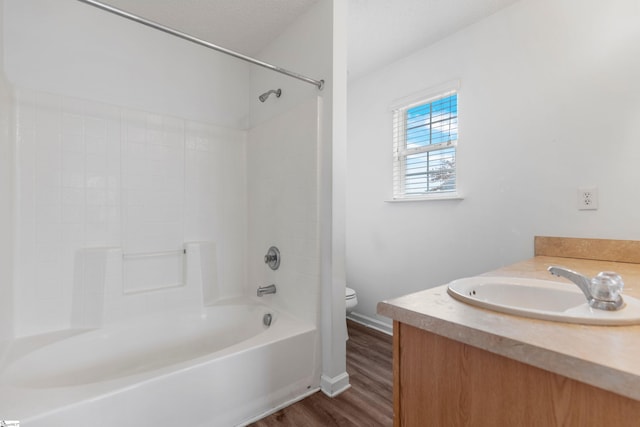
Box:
(378, 256), (640, 400)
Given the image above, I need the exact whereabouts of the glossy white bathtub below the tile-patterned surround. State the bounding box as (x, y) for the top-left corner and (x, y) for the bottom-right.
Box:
(0, 300), (319, 427)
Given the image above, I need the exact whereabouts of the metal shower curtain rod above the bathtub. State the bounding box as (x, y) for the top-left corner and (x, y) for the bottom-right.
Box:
(78, 0), (324, 90)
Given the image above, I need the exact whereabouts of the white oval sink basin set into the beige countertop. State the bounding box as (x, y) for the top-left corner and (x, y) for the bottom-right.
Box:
(447, 276), (640, 326)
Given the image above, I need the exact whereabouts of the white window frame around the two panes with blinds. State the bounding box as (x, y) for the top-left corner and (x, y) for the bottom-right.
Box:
(389, 81), (462, 202)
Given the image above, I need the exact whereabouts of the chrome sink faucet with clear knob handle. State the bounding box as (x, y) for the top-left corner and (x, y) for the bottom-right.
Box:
(547, 266), (624, 311)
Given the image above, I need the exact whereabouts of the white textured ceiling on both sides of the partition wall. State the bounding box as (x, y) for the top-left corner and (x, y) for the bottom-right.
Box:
(90, 0), (517, 79)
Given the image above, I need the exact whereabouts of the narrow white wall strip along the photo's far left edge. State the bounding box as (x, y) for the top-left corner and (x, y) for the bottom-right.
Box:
(0, 0), (14, 348)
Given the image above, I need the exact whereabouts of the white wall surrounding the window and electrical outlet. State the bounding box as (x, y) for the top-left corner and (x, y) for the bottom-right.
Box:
(347, 0), (640, 330)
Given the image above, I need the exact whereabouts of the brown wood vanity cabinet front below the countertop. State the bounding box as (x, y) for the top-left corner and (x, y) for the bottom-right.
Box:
(393, 321), (640, 427)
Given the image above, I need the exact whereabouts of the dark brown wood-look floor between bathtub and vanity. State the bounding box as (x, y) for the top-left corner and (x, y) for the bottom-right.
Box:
(251, 321), (393, 427)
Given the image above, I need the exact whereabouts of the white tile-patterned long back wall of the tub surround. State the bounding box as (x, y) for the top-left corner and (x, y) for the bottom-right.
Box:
(15, 89), (246, 337)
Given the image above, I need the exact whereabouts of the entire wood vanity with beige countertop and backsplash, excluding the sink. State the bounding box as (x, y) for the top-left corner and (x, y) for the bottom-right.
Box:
(378, 236), (640, 427)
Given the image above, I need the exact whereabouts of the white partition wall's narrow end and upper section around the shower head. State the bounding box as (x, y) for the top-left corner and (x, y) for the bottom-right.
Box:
(249, 0), (348, 394)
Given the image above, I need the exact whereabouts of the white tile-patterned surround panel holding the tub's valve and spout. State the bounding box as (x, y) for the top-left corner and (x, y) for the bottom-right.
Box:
(247, 97), (320, 325)
